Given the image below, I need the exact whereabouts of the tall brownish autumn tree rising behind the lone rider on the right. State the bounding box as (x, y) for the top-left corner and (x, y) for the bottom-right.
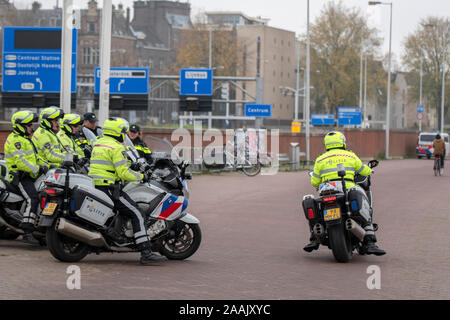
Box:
(311, 2), (386, 113)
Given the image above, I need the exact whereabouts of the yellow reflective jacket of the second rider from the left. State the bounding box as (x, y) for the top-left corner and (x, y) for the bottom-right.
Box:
(33, 127), (66, 167)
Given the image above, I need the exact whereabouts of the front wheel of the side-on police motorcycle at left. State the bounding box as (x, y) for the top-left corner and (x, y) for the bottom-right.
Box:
(159, 223), (202, 260)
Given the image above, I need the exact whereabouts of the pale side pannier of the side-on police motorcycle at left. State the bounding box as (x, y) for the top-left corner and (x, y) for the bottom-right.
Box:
(70, 186), (114, 226)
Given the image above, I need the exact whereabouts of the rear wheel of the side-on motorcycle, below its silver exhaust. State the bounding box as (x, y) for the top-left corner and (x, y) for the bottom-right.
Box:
(46, 226), (89, 262)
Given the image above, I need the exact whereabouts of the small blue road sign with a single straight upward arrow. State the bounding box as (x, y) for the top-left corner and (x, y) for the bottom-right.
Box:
(180, 69), (213, 96)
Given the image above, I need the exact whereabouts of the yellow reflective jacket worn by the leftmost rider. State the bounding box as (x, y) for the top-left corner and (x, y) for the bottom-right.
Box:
(4, 132), (45, 181)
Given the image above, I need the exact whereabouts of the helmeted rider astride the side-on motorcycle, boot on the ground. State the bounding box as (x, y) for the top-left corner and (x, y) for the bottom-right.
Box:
(88, 118), (164, 264)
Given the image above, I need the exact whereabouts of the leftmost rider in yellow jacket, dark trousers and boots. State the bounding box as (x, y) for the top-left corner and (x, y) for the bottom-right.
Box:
(4, 110), (48, 244)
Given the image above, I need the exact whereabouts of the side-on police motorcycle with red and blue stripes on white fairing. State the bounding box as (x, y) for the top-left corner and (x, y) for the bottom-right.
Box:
(40, 132), (202, 262)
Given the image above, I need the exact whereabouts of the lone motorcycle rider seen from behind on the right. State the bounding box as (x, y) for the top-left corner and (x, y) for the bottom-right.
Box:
(303, 131), (386, 255)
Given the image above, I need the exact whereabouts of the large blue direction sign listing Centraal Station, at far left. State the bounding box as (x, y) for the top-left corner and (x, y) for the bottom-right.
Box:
(2, 27), (77, 93)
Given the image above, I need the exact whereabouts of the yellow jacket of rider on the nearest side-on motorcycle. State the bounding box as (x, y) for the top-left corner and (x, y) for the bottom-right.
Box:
(88, 136), (144, 186)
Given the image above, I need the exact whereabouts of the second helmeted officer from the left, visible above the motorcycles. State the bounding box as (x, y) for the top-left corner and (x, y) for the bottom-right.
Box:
(33, 106), (66, 167)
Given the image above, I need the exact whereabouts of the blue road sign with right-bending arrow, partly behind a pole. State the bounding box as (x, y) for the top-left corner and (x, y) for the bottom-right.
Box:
(94, 68), (149, 94)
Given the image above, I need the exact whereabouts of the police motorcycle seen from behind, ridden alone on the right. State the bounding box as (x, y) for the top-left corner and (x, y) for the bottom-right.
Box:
(302, 160), (378, 262)
